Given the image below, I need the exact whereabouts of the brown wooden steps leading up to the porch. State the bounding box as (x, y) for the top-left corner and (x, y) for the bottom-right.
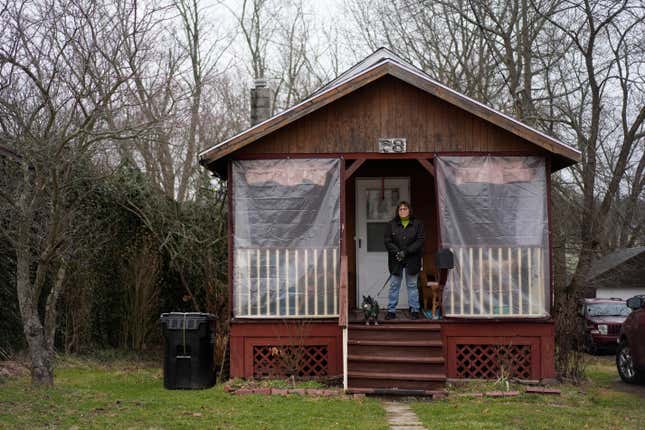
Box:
(347, 320), (446, 392)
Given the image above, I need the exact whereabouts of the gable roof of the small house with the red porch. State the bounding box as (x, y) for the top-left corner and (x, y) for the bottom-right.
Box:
(199, 48), (580, 170)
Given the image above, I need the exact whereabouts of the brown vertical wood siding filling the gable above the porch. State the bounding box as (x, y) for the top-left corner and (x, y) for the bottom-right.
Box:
(237, 76), (546, 156)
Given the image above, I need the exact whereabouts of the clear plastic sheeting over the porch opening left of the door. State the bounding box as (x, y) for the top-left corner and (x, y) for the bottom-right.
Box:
(232, 159), (340, 318)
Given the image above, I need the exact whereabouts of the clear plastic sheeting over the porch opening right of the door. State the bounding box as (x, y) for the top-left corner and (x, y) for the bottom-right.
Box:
(435, 156), (550, 318)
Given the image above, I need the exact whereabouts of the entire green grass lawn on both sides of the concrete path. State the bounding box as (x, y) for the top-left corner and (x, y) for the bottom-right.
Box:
(0, 356), (645, 430)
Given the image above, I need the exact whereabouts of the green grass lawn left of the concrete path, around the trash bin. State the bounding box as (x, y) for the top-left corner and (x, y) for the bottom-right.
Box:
(0, 360), (388, 430)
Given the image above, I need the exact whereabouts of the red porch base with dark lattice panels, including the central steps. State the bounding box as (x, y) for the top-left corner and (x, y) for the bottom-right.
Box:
(231, 310), (555, 395)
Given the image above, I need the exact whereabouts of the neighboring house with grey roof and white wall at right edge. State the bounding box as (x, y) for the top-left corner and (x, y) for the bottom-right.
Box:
(585, 246), (645, 300)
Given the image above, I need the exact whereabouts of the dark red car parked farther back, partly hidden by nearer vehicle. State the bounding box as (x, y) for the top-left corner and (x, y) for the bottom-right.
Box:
(578, 299), (631, 354)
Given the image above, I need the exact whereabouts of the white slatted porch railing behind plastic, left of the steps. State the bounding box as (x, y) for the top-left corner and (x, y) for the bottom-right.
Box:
(234, 248), (339, 318)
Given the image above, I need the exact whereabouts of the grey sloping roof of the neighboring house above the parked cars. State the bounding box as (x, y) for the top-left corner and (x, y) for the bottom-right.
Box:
(587, 246), (645, 286)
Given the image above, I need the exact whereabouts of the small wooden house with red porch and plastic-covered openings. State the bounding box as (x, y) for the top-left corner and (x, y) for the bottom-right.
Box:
(200, 49), (580, 392)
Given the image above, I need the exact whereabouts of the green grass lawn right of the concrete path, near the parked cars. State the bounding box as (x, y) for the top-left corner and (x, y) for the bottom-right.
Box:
(412, 356), (645, 430)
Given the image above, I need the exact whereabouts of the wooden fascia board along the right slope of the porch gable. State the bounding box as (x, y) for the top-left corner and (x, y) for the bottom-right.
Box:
(388, 65), (581, 162)
